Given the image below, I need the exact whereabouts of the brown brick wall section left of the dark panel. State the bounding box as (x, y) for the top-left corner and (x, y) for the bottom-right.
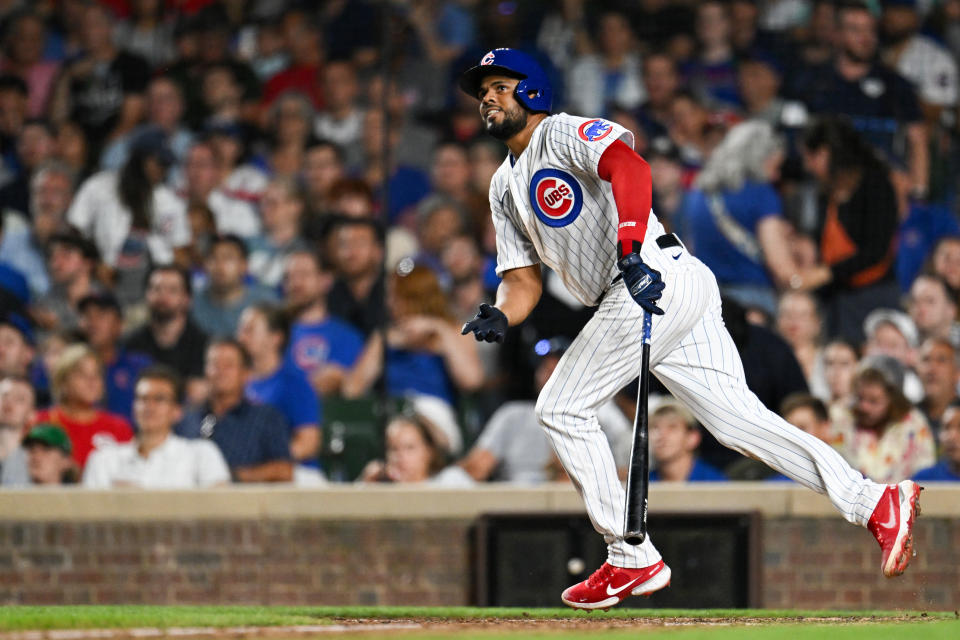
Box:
(0, 520), (470, 605)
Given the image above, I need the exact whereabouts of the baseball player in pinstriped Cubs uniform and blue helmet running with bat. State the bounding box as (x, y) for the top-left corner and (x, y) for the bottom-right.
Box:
(460, 49), (921, 609)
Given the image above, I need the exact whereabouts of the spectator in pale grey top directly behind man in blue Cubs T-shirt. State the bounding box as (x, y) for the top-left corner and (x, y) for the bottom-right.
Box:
(250, 177), (309, 287)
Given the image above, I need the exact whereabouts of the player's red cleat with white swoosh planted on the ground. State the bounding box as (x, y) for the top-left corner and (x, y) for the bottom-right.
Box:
(560, 560), (670, 609)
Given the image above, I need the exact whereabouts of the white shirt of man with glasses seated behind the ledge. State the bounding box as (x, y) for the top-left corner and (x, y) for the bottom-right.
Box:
(83, 434), (230, 489)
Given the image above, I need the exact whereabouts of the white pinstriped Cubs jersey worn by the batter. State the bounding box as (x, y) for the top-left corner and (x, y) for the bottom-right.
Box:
(490, 113), (664, 306)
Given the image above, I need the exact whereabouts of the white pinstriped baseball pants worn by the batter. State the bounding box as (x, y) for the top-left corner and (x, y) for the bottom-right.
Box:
(537, 248), (884, 567)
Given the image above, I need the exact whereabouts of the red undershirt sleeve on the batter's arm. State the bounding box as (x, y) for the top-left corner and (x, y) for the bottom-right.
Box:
(597, 140), (653, 257)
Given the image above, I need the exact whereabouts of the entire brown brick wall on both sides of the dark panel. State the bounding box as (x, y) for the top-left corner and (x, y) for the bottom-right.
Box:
(0, 517), (960, 610)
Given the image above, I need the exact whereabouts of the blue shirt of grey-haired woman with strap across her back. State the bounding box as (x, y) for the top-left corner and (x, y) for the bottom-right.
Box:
(678, 182), (783, 287)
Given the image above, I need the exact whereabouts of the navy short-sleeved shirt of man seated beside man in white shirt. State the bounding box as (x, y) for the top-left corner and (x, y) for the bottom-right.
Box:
(176, 400), (290, 469)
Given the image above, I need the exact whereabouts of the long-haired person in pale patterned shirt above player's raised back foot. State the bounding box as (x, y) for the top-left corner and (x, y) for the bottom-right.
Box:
(834, 356), (936, 482)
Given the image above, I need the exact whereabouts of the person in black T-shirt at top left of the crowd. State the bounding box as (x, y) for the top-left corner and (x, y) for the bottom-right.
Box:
(50, 4), (150, 156)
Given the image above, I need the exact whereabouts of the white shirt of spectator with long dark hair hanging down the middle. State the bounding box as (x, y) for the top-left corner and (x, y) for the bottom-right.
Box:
(67, 171), (190, 267)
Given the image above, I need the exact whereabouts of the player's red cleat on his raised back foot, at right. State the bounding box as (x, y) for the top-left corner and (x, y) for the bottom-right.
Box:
(867, 480), (923, 578)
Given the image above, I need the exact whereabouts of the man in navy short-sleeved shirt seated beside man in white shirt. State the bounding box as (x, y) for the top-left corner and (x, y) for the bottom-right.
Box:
(176, 339), (293, 482)
